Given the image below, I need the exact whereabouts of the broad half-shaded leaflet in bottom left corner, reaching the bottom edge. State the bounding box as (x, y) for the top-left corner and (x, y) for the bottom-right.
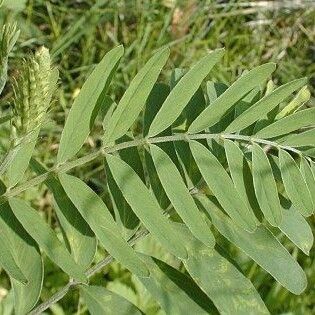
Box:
(0, 203), (44, 315)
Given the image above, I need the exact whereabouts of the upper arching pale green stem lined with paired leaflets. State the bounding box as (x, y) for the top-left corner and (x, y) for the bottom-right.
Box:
(0, 133), (311, 204)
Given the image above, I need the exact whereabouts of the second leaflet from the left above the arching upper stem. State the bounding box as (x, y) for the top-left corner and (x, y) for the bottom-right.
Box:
(104, 48), (170, 143)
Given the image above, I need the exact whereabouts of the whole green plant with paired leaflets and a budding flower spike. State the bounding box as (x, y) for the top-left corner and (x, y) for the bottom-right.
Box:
(0, 22), (315, 314)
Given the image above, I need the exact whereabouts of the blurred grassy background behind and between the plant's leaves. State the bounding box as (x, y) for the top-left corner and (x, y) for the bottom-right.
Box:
(0, 0), (315, 315)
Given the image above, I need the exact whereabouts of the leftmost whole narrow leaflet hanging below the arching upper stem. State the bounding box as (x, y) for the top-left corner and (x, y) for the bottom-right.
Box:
(9, 198), (86, 282)
